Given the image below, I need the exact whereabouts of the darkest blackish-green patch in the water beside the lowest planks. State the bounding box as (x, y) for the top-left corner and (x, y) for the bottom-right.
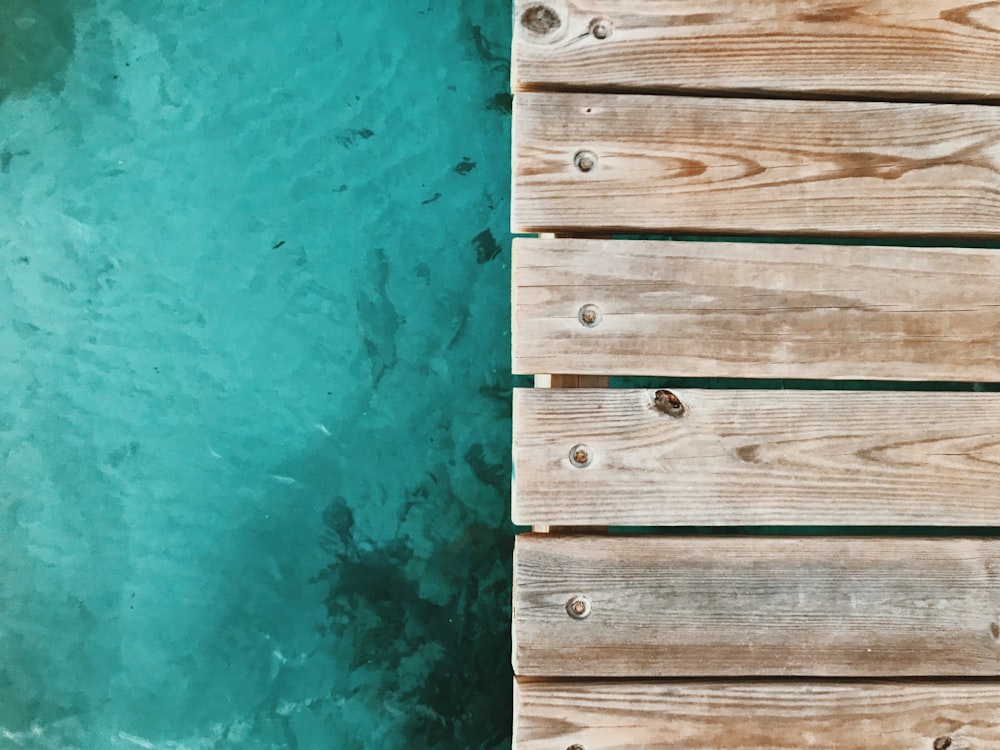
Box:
(316, 490), (512, 748)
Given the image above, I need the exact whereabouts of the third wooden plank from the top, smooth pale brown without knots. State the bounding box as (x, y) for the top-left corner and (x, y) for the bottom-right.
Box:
(512, 239), (1000, 381)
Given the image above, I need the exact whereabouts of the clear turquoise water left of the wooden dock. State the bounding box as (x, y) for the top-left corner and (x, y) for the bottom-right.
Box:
(0, 0), (511, 750)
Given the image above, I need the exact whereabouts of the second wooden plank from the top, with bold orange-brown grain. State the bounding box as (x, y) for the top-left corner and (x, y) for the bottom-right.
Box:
(512, 94), (1000, 237)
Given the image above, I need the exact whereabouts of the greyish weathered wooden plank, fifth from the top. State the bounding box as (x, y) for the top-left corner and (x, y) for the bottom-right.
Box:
(513, 534), (1000, 678)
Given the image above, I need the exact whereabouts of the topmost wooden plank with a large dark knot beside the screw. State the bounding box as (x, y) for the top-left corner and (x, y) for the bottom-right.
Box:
(512, 0), (1000, 100)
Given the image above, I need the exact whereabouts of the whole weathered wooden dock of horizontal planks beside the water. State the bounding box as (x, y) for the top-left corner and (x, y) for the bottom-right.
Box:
(512, 0), (1000, 750)
